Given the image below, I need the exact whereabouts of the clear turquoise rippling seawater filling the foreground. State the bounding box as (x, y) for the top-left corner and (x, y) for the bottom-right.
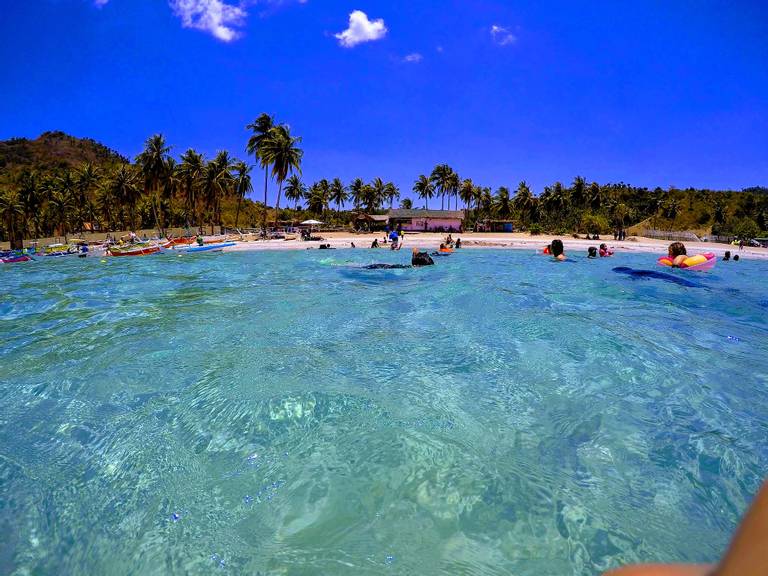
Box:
(0, 250), (768, 575)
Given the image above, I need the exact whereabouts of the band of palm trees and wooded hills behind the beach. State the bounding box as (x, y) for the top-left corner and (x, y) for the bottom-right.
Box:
(0, 121), (768, 245)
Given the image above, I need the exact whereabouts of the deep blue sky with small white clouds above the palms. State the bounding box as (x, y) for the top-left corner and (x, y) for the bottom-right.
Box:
(0, 0), (768, 205)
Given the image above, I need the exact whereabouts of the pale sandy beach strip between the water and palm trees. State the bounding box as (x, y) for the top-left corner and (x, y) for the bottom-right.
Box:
(226, 232), (768, 260)
